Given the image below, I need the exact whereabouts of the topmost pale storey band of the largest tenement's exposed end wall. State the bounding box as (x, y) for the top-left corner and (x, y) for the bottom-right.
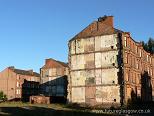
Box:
(69, 34), (118, 55)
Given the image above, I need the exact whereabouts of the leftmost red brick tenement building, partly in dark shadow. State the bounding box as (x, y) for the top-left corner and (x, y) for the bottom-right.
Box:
(0, 67), (40, 101)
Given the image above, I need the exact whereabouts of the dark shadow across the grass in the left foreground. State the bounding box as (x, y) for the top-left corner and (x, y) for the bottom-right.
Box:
(0, 106), (113, 116)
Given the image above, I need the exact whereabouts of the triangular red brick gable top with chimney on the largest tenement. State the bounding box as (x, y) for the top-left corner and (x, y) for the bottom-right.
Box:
(70, 16), (123, 41)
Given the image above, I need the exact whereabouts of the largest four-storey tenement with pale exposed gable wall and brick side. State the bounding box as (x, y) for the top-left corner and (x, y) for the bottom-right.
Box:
(68, 16), (154, 105)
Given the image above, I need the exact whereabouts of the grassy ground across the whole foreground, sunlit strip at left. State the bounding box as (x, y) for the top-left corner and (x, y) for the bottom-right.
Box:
(0, 102), (154, 116)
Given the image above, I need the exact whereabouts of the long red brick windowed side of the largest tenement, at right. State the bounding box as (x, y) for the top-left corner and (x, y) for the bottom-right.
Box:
(122, 32), (154, 101)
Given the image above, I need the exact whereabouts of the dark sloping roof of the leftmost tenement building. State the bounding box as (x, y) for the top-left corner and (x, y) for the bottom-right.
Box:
(9, 67), (40, 77)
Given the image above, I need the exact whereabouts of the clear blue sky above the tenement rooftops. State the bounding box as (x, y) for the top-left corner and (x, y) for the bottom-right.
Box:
(0, 0), (154, 72)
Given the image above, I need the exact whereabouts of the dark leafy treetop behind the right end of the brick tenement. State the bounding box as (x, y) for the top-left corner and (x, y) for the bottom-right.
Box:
(142, 37), (154, 54)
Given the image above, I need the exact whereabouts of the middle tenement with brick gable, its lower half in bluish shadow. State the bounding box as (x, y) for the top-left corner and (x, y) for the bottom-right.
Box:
(40, 59), (68, 102)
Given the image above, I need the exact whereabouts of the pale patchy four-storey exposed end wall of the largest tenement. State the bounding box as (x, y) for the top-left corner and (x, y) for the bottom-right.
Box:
(69, 34), (120, 105)
